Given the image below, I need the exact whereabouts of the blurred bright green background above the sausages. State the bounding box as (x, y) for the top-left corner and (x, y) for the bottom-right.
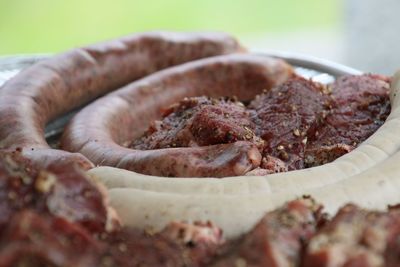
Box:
(0, 0), (340, 55)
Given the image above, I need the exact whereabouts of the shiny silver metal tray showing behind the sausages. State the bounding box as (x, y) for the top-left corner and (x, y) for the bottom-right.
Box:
(0, 51), (361, 144)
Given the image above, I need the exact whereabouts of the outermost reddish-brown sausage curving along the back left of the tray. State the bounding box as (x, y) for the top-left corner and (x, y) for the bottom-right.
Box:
(0, 32), (243, 168)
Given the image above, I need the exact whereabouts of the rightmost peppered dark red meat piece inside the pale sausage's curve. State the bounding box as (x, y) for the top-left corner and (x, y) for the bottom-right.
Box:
(306, 75), (390, 167)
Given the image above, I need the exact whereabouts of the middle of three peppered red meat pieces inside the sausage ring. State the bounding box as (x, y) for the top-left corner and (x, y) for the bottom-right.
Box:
(249, 77), (330, 170)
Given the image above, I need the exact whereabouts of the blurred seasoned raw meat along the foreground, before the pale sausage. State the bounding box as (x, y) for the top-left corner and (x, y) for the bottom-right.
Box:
(0, 153), (400, 267)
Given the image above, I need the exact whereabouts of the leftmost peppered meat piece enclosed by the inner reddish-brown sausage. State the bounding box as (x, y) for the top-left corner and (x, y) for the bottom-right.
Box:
(131, 97), (263, 150)
